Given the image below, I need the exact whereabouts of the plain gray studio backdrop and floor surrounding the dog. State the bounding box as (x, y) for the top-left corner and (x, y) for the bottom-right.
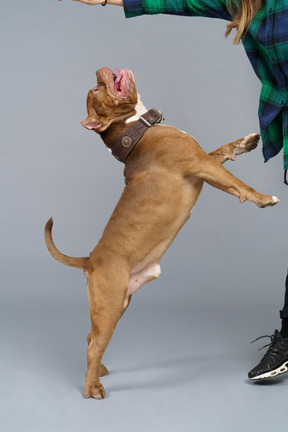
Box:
(0, 0), (288, 432)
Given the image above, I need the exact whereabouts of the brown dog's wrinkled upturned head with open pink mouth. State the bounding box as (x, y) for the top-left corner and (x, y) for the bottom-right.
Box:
(81, 67), (138, 133)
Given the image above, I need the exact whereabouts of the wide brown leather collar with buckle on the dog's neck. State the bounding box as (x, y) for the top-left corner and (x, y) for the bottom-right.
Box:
(112, 108), (164, 163)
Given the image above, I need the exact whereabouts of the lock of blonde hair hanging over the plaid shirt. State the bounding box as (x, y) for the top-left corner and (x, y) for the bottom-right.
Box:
(225, 0), (261, 45)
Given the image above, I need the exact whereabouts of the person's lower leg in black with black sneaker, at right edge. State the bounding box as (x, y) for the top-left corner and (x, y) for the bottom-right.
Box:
(248, 273), (288, 380)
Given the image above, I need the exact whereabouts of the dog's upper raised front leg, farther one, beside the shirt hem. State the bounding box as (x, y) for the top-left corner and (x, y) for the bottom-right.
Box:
(209, 134), (260, 164)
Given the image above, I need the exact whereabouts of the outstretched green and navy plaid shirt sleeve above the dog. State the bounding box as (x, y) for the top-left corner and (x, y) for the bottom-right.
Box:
(123, 0), (231, 21)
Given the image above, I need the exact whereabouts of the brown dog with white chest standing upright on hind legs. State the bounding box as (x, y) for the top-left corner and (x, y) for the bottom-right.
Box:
(45, 68), (279, 399)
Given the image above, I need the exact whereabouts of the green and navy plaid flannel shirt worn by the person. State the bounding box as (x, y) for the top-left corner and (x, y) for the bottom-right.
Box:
(123, 0), (288, 174)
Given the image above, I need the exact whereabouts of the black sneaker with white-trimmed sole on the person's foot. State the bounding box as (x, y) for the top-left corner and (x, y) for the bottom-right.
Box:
(248, 330), (288, 380)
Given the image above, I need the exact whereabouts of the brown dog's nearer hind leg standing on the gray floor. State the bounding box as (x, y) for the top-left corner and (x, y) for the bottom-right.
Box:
(84, 269), (129, 399)
